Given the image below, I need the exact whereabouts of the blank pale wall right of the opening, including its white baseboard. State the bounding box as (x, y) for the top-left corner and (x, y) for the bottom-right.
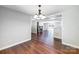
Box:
(62, 6), (79, 48)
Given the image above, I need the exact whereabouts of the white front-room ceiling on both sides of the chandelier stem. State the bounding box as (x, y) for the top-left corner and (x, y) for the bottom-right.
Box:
(3, 5), (72, 16)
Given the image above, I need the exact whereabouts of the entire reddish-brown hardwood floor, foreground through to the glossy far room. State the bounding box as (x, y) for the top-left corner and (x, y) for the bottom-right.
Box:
(0, 32), (79, 54)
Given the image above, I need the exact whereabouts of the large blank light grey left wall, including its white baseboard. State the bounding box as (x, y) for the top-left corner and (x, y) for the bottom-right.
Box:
(0, 6), (31, 50)
